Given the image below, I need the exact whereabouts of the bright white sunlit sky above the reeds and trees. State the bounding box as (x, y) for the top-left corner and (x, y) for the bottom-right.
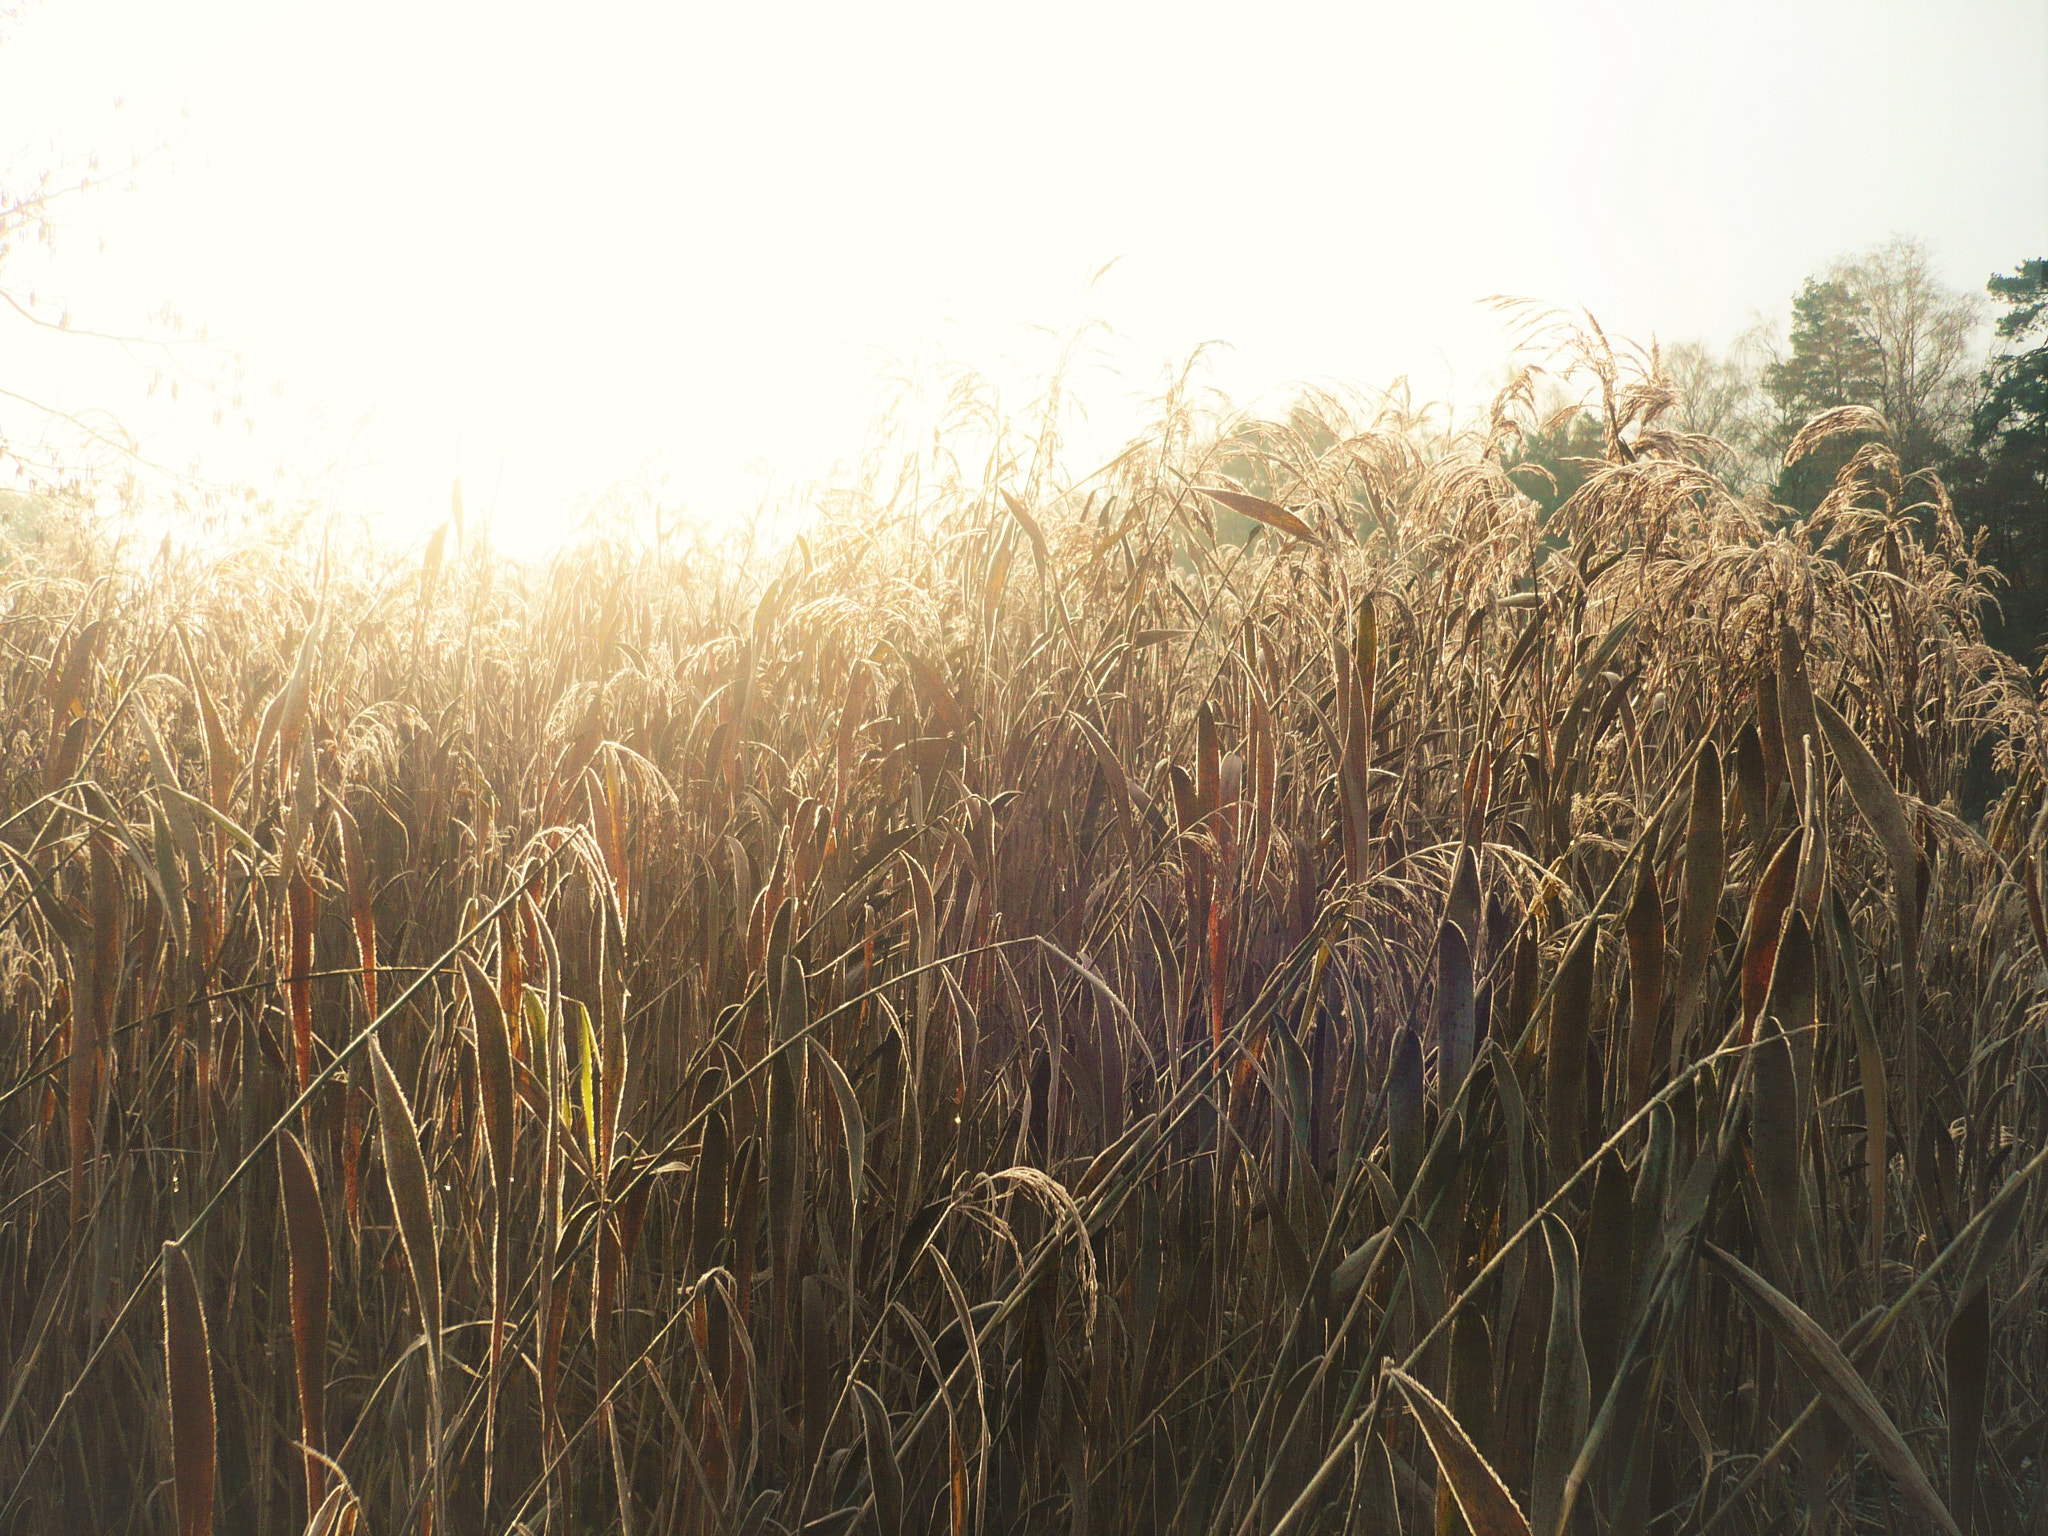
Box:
(0, 0), (2048, 547)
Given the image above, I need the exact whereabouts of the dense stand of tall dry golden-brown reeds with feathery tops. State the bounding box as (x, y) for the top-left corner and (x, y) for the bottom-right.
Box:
(0, 336), (2048, 1536)
